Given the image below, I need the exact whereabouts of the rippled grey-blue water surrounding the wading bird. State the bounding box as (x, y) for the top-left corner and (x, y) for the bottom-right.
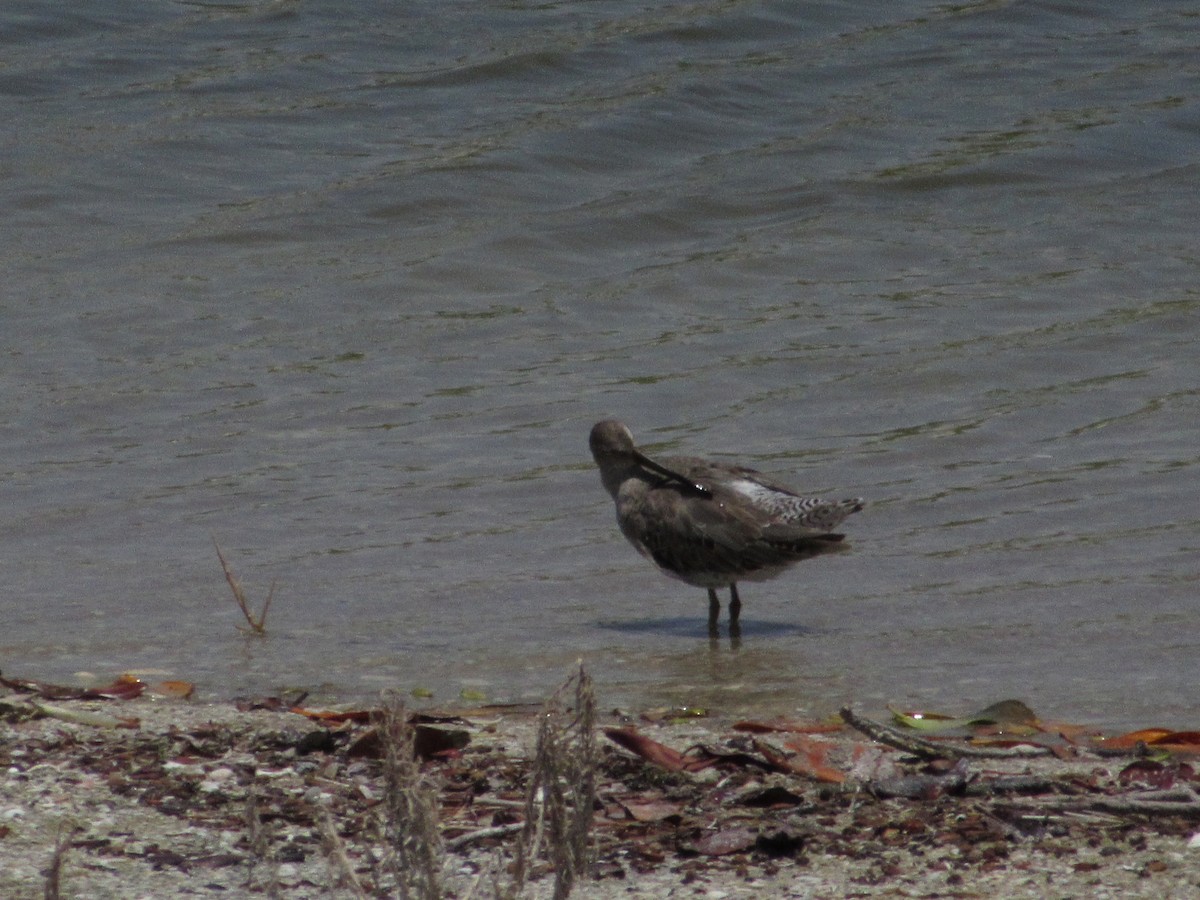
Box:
(0, 0), (1200, 727)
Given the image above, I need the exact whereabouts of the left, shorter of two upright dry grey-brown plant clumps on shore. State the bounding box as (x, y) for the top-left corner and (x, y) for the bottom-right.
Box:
(377, 692), (443, 900)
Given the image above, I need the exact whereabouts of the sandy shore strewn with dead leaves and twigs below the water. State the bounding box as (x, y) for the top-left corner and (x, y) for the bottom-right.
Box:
(0, 692), (1200, 900)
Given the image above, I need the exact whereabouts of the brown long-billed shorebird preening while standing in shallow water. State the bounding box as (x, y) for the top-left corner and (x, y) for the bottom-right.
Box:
(588, 419), (863, 636)
